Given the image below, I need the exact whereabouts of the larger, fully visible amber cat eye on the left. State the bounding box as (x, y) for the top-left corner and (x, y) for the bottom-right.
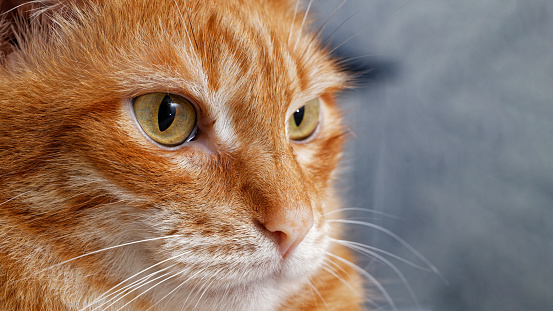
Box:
(133, 93), (197, 147)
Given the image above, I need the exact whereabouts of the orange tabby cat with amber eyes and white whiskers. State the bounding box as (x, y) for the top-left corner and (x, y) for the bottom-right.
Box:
(0, 0), (367, 311)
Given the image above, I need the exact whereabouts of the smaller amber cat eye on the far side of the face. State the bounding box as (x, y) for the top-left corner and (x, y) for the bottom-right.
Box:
(288, 98), (320, 141)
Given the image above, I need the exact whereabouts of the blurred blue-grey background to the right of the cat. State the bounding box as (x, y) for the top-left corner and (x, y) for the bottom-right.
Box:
(312, 0), (553, 311)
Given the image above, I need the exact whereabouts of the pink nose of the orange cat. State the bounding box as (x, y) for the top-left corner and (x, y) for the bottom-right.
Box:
(260, 209), (313, 258)
